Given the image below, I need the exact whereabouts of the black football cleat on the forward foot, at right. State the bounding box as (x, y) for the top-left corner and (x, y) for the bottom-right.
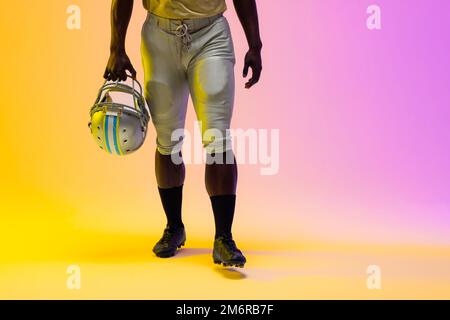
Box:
(213, 236), (247, 268)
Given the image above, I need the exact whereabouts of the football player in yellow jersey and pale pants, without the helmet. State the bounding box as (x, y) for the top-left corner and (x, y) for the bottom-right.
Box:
(104, 0), (262, 267)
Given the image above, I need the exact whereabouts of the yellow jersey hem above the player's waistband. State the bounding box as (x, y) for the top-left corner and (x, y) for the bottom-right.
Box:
(143, 0), (227, 19)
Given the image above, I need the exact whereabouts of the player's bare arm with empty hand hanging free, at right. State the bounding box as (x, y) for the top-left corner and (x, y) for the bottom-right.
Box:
(233, 0), (262, 89)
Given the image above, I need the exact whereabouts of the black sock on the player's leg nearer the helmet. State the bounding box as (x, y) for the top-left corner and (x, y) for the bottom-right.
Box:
(158, 185), (184, 229)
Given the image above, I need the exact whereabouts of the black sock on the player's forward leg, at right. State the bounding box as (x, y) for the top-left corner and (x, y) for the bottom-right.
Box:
(210, 194), (236, 239)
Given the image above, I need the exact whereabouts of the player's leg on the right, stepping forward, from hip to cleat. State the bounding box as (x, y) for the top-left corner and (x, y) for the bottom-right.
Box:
(187, 17), (245, 266)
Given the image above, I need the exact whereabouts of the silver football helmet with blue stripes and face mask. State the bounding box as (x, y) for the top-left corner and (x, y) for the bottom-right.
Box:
(89, 76), (150, 156)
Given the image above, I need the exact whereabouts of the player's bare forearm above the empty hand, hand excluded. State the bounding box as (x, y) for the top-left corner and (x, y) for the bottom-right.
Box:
(233, 0), (262, 49)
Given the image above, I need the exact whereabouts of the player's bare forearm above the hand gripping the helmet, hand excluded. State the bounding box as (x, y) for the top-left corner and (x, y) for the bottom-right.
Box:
(111, 0), (134, 52)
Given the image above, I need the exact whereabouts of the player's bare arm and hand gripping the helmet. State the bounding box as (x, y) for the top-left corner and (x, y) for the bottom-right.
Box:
(103, 0), (136, 81)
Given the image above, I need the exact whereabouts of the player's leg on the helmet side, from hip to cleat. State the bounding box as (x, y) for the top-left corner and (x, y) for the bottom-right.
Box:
(141, 15), (189, 257)
